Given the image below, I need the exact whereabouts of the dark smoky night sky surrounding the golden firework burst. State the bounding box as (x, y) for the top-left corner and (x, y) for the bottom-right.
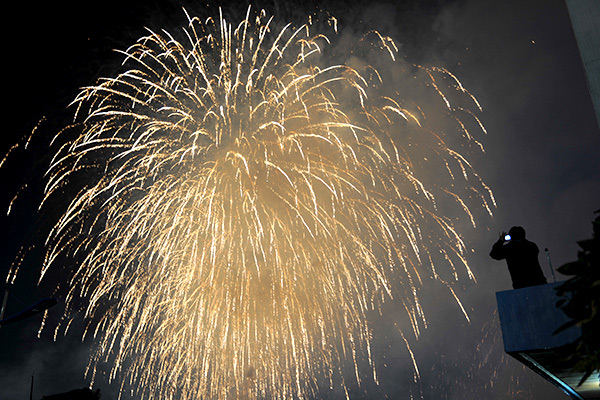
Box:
(0, 0), (600, 400)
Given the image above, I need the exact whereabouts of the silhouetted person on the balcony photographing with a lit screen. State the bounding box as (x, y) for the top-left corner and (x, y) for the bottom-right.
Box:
(490, 226), (547, 289)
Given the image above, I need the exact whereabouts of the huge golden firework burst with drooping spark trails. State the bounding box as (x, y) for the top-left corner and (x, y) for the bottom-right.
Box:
(17, 10), (493, 399)
